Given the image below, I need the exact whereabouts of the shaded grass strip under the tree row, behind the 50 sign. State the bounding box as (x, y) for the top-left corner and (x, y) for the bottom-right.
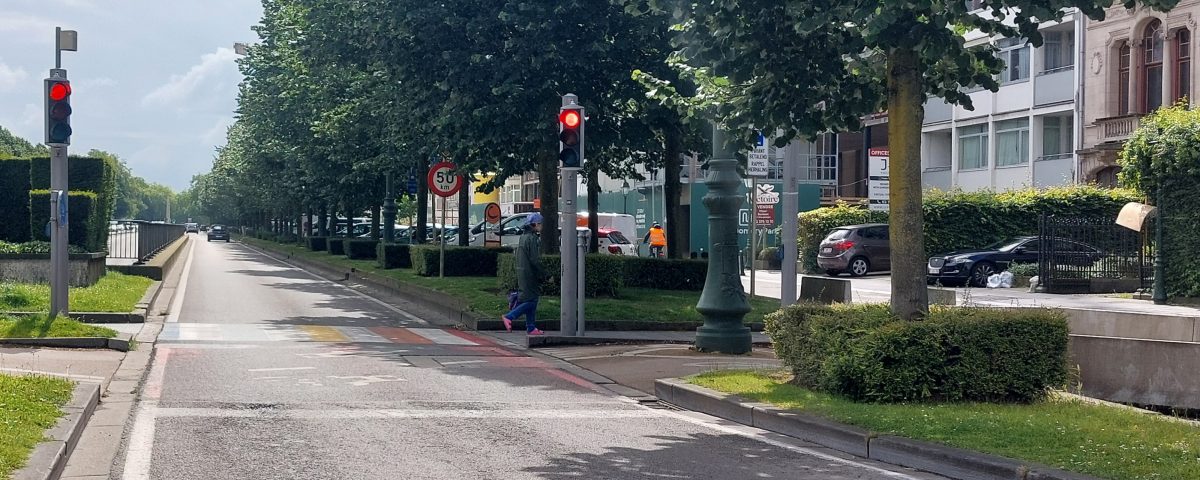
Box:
(240, 236), (779, 323)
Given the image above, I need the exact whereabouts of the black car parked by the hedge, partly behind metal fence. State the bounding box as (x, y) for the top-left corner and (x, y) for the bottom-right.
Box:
(929, 236), (1104, 288)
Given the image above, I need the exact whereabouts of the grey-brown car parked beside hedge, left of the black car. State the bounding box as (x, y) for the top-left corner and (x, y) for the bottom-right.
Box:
(817, 223), (892, 277)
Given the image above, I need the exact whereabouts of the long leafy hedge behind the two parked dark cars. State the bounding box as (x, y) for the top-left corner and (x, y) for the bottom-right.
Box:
(797, 185), (1139, 272)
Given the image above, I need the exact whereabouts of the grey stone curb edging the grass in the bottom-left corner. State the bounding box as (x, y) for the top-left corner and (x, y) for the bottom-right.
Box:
(12, 383), (100, 480)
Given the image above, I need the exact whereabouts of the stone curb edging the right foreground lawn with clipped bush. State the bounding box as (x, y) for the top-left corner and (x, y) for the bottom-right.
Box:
(654, 378), (1099, 480)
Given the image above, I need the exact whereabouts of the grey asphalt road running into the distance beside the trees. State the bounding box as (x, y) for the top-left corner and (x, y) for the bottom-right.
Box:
(113, 239), (934, 480)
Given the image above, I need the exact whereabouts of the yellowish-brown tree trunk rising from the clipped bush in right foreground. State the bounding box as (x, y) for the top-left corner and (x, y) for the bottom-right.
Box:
(888, 48), (929, 320)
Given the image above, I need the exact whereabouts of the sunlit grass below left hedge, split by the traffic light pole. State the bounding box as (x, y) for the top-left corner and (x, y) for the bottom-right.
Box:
(0, 271), (154, 312)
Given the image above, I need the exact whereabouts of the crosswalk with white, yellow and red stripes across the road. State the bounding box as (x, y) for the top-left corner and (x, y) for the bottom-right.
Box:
(158, 323), (490, 346)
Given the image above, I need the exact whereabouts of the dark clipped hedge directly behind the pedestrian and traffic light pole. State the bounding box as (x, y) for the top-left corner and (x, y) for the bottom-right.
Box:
(496, 253), (625, 298)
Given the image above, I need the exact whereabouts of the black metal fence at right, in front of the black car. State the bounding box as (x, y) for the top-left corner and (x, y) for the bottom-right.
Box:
(1038, 216), (1154, 293)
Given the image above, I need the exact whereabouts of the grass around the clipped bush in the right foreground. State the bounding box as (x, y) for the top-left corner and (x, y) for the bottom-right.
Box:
(690, 371), (1200, 480)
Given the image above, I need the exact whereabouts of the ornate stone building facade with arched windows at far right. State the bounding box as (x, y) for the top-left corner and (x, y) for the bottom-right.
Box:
(1080, 0), (1200, 185)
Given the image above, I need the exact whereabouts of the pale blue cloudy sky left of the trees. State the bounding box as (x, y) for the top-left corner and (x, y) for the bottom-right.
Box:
(0, 0), (263, 191)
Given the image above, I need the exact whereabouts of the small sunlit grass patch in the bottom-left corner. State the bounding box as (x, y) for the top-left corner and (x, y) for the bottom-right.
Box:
(0, 374), (73, 479)
